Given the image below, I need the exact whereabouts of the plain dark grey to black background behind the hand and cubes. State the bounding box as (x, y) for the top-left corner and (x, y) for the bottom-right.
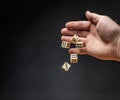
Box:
(0, 0), (120, 100)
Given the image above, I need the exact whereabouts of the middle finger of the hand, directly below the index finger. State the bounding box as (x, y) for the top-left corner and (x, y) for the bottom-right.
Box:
(61, 28), (88, 37)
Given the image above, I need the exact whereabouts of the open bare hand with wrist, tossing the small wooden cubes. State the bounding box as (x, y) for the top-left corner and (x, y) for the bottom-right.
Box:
(61, 11), (120, 61)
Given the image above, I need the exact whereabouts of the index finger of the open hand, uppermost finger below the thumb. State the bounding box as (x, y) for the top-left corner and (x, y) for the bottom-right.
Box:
(65, 21), (91, 30)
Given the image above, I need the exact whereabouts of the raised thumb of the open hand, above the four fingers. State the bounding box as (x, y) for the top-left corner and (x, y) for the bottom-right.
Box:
(86, 11), (101, 24)
